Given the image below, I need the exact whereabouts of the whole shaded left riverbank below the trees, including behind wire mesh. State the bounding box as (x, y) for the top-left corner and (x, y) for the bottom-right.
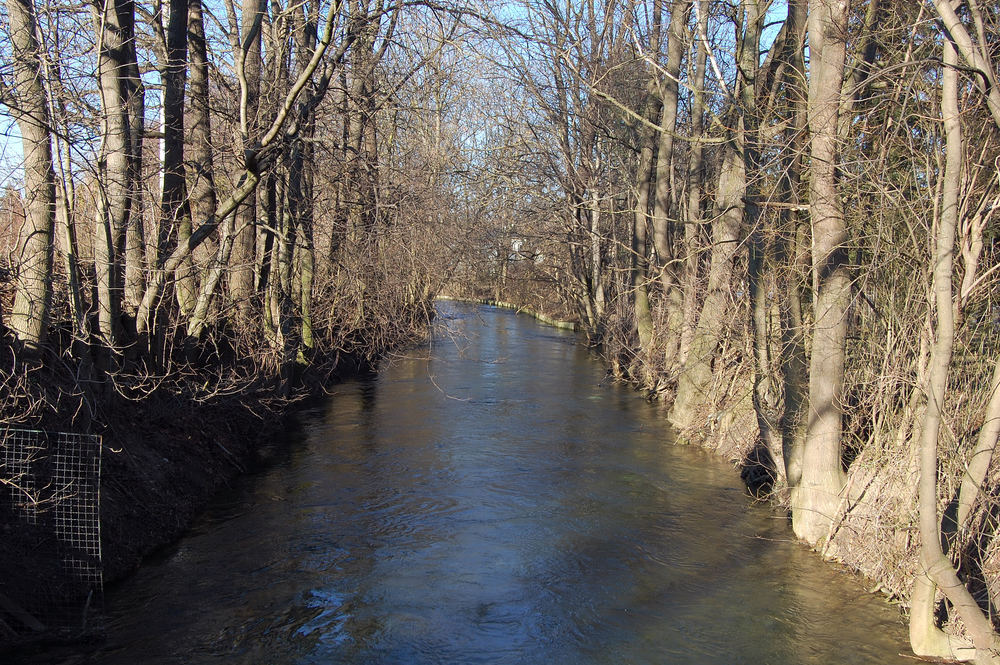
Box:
(0, 321), (418, 660)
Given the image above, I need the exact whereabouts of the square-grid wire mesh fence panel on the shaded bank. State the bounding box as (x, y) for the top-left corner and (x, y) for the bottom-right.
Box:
(0, 429), (103, 643)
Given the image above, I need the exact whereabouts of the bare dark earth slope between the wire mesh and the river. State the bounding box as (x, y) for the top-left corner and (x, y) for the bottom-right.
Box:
(100, 356), (372, 582)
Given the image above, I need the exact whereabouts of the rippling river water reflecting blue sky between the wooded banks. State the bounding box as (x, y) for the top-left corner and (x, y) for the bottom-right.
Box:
(64, 304), (912, 665)
